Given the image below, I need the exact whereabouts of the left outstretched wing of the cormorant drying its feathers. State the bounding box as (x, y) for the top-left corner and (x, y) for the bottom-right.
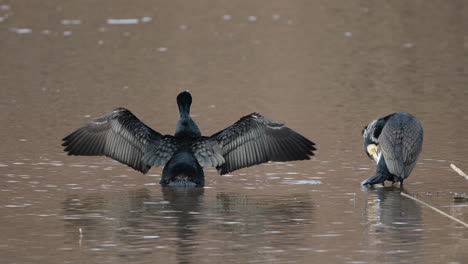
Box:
(62, 108), (168, 173)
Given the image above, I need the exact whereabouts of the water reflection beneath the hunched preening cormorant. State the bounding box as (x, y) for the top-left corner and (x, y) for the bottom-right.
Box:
(364, 187), (424, 262)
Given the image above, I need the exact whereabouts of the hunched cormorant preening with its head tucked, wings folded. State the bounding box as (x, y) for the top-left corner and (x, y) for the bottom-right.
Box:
(361, 113), (423, 186)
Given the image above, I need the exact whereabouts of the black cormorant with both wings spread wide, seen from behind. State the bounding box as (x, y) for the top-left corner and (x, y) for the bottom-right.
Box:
(63, 91), (315, 186)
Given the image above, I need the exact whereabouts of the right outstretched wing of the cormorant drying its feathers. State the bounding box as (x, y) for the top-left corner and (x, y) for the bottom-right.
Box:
(195, 113), (315, 174)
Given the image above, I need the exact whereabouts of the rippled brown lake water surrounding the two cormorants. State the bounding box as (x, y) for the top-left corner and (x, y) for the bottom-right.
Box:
(0, 0), (468, 264)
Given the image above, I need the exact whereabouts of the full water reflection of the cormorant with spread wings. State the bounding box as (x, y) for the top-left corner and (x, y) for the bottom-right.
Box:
(63, 187), (313, 263)
